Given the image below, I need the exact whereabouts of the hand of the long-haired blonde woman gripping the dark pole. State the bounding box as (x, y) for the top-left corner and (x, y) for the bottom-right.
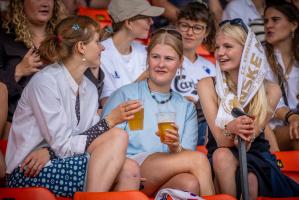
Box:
(226, 115), (255, 142)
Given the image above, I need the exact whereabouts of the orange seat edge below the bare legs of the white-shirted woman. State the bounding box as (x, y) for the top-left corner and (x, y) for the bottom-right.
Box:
(74, 191), (149, 200)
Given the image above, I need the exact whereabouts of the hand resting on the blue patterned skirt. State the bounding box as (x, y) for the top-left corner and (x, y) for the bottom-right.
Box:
(20, 148), (50, 177)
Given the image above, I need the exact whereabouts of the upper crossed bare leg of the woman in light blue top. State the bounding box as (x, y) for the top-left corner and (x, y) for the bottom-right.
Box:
(141, 151), (215, 195)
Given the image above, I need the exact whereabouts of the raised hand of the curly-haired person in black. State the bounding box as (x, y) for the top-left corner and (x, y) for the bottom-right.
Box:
(15, 47), (43, 82)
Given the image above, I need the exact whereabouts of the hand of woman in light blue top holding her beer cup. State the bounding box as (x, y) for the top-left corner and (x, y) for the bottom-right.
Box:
(156, 124), (182, 153)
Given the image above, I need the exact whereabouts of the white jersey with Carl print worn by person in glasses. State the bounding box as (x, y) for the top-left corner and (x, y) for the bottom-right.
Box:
(171, 56), (216, 101)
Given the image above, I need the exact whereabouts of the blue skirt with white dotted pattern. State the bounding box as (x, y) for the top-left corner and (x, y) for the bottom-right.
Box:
(6, 153), (89, 197)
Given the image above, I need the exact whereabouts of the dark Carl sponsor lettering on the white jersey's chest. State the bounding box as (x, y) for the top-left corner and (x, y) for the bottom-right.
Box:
(174, 75), (197, 95)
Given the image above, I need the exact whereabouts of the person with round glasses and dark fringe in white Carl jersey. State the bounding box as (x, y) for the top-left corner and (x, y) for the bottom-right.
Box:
(171, 2), (216, 145)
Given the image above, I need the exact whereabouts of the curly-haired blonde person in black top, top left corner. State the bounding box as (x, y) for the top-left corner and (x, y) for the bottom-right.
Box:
(0, 0), (64, 122)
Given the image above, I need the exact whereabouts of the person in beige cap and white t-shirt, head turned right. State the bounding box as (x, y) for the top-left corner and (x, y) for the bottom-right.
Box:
(101, 0), (164, 105)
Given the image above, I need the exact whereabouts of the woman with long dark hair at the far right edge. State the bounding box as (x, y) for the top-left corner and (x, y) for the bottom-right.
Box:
(265, 2), (299, 150)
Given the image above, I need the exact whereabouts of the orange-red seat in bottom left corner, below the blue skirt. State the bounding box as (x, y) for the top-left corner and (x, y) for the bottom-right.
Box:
(0, 187), (56, 200)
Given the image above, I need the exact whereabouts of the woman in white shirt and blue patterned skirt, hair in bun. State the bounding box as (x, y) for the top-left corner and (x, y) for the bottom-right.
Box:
(6, 16), (141, 197)
